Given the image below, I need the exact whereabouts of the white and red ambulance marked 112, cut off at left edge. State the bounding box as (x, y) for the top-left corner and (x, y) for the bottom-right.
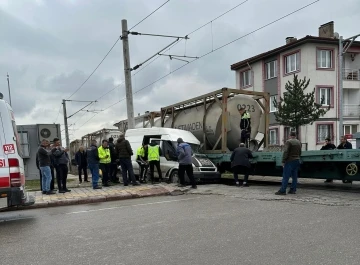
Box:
(0, 93), (35, 207)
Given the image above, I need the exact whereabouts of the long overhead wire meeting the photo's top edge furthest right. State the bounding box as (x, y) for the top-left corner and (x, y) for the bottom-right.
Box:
(77, 0), (320, 126)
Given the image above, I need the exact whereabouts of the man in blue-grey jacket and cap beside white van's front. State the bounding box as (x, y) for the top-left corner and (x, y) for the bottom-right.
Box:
(176, 138), (197, 189)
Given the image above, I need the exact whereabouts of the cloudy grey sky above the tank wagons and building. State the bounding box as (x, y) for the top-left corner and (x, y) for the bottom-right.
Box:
(0, 0), (360, 143)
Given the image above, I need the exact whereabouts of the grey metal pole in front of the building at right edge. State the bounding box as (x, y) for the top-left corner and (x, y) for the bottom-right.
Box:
(339, 34), (360, 142)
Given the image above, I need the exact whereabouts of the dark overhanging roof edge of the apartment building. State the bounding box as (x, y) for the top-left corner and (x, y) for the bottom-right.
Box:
(231, 35), (360, 70)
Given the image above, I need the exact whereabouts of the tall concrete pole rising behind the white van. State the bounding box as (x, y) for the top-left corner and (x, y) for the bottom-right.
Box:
(121, 19), (135, 129)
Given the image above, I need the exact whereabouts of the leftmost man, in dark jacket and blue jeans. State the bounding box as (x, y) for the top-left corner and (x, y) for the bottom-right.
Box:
(37, 139), (55, 195)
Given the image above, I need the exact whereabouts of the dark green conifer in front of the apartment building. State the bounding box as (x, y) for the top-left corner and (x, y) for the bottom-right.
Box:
(273, 75), (330, 136)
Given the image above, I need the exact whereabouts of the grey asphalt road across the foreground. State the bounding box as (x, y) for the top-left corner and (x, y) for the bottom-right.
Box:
(0, 195), (360, 265)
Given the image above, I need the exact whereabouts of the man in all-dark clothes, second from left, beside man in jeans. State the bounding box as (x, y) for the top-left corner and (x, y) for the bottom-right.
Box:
(51, 138), (71, 193)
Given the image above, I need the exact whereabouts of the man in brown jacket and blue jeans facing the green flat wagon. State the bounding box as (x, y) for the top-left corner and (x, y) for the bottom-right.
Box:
(275, 132), (301, 195)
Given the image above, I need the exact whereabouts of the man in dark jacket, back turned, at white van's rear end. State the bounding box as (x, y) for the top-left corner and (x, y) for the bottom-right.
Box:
(115, 134), (140, 186)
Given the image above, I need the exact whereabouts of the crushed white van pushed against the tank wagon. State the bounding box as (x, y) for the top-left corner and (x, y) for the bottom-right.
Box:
(125, 127), (220, 183)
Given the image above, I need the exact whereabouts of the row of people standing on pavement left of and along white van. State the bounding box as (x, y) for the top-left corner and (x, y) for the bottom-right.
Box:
(36, 135), (197, 195)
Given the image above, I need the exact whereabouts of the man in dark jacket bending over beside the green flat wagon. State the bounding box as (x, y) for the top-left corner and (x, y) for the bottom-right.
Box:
(230, 143), (253, 187)
